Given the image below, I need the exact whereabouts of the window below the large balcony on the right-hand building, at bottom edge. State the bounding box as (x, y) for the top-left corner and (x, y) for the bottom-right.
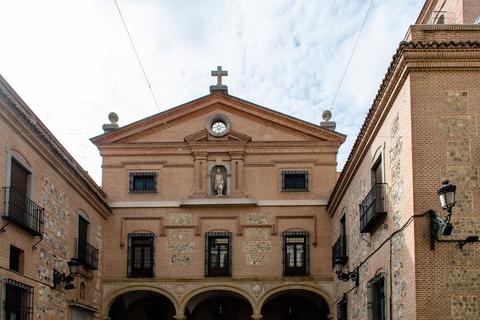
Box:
(367, 272), (387, 320)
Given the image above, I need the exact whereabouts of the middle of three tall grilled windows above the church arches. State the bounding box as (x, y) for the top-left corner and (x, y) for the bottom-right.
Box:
(205, 232), (232, 277)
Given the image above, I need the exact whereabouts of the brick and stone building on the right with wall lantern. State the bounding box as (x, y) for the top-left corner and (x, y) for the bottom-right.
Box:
(328, 0), (480, 319)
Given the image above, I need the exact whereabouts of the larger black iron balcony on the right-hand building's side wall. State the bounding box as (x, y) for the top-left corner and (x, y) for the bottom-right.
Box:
(360, 183), (387, 233)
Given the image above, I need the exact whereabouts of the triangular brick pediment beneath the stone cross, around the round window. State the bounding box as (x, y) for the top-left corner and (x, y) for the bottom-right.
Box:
(91, 93), (345, 145)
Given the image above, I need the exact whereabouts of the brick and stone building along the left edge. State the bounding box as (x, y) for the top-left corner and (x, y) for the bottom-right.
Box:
(0, 77), (111, 320)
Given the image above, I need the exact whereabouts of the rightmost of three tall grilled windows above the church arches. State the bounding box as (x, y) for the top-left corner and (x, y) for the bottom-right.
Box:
(283, 232), (308, 276)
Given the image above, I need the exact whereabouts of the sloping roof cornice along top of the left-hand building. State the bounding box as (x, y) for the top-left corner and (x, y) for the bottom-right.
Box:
(0, 76), (111, 217)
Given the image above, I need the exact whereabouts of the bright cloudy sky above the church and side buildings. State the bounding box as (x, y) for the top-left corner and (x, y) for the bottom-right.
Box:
(0, 0), (424, 183)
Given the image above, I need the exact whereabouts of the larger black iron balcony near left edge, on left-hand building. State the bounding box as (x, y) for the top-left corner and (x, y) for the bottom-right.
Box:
(3, 187), (44, 236)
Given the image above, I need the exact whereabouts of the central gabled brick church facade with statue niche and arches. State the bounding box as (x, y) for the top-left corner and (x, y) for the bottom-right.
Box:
(92, 86), (344, 319)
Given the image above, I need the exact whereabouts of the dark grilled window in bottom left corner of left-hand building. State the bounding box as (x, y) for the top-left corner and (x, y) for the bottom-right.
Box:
(5, 279), (33, 320)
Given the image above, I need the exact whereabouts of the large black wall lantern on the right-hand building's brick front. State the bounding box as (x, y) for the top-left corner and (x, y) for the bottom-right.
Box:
(430, 180), (457, 250)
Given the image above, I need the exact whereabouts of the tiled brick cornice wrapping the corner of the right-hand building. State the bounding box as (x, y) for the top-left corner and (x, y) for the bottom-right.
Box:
(327, 41), (480, 215)
